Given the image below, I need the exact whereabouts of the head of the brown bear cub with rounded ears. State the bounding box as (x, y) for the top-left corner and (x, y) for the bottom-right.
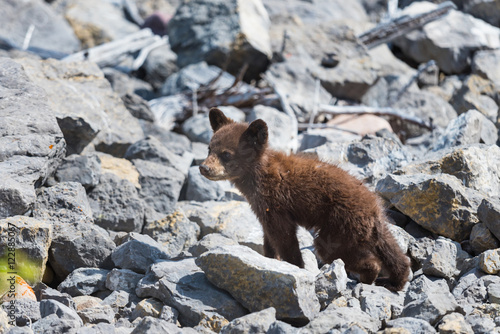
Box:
(200, 108), (268, 181)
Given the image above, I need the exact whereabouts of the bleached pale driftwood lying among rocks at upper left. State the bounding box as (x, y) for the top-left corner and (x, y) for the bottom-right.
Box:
(62, 28), (161, 67)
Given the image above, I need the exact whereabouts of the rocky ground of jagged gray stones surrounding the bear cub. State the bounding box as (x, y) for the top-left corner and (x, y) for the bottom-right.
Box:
(0, 0), (500, 334)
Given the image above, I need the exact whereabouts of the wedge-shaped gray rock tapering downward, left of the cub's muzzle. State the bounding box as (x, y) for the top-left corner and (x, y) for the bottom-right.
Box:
(133, 159), (187, 214)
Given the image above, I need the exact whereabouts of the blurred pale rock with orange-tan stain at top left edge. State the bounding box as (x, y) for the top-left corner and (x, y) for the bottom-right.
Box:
(58, 0), (139, 48)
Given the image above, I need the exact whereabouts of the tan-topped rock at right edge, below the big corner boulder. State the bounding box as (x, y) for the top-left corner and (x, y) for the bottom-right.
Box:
(450, 74), (500, 122)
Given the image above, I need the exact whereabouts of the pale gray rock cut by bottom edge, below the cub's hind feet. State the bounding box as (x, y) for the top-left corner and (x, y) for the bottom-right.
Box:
(300, 304), (381, 334)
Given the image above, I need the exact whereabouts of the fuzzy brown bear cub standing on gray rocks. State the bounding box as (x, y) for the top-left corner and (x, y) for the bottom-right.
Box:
(200, 108), (410, 291)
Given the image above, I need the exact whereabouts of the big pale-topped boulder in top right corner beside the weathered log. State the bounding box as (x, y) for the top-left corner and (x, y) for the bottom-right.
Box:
(394, 2), (500, 74)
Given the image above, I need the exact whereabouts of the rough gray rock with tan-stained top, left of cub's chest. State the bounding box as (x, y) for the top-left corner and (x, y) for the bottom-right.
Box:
(142, 209), (200, 257)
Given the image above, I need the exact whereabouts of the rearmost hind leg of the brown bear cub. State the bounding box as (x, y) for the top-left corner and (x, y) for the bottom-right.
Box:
(376, 223), (410, 291)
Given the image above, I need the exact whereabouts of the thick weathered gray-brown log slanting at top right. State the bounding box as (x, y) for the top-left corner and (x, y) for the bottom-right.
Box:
(358, 1), (457, 49)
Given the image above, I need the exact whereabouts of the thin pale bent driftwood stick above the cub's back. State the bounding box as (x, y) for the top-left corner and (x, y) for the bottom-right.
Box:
(319, 104), (434, 131)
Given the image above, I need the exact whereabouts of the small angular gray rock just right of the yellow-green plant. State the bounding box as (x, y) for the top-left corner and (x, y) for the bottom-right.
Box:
(57, 268), (109, 297)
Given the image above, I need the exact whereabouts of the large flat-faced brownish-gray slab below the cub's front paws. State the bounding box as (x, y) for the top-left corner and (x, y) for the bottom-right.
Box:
(196, 246), (320, 321)
